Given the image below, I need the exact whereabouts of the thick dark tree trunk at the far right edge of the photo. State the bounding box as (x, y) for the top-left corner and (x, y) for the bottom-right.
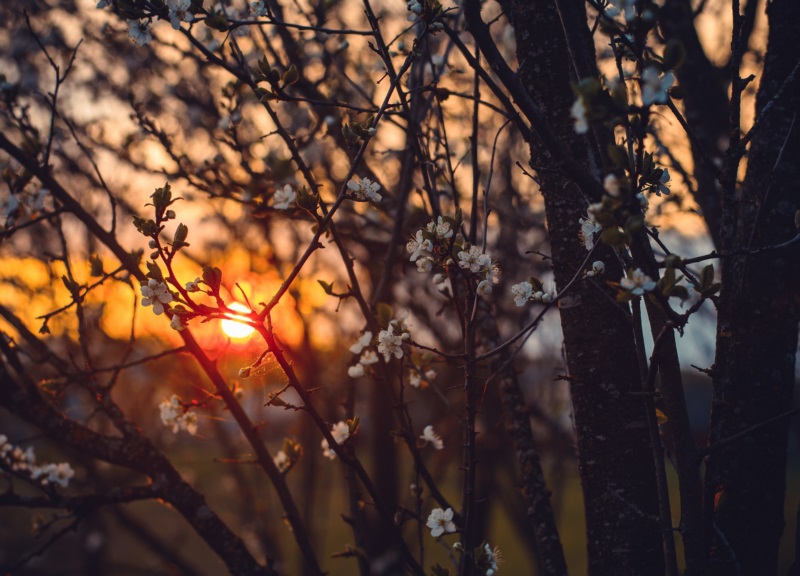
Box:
(707, 0), (800, 575)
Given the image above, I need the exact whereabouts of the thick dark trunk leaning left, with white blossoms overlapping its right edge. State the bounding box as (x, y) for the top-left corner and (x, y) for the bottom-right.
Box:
(505, 1), (664, 576)
